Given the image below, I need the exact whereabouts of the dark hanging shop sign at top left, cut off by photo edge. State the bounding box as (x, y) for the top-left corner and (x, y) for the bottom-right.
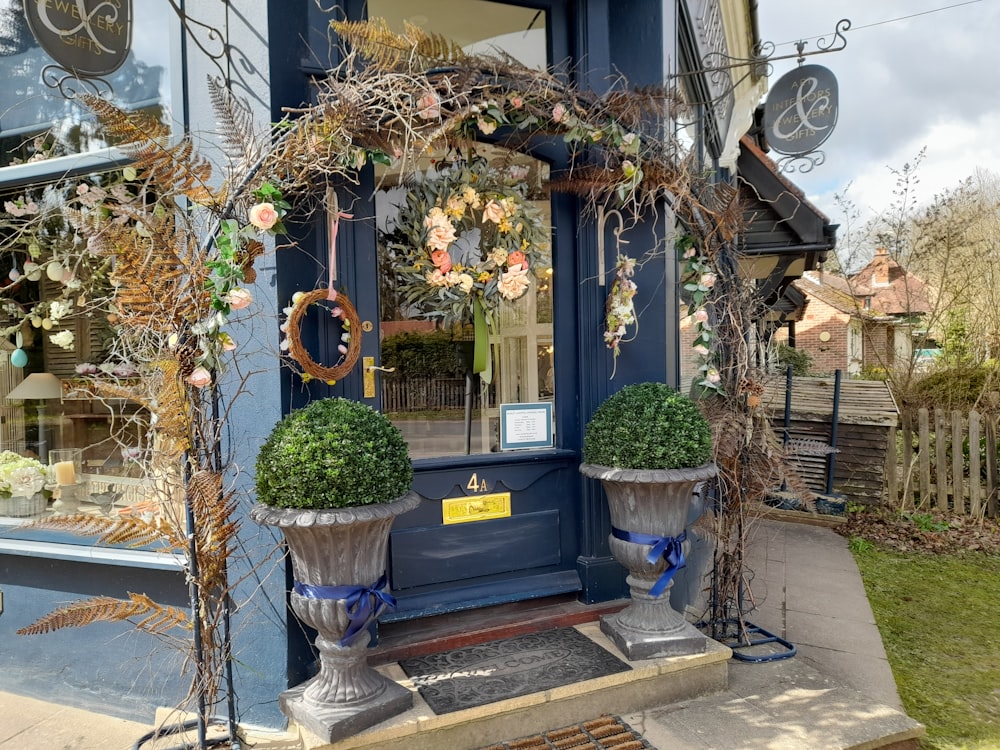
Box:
(24, 0), (133, 77)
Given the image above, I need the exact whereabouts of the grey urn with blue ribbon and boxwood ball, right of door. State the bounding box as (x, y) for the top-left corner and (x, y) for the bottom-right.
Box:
(580, 383), (716, 660)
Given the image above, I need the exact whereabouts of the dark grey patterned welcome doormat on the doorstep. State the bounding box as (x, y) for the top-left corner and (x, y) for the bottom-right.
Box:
(399, 628), (632, 715)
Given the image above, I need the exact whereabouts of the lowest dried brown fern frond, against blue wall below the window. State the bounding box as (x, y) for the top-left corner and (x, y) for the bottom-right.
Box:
(17, 592), (190, 635)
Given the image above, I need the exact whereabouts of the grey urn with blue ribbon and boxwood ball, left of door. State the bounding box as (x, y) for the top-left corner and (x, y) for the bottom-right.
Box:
(250, 398), (420, 742)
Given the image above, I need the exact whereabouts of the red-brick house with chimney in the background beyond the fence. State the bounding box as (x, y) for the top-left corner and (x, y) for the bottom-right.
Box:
(778, 248), (931, 375)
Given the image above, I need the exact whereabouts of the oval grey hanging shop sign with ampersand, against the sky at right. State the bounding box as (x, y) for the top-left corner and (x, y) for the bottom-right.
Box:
(764, 65), (839, 155)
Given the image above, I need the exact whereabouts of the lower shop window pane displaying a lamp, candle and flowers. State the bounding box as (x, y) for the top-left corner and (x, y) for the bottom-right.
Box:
(0, 175), (158, 528)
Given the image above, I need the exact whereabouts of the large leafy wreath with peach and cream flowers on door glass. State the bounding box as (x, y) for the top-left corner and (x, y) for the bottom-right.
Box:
(380, 157), (551, 326)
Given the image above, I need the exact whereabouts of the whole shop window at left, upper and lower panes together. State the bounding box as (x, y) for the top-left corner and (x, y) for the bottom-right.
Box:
(0, 2), (183, 544)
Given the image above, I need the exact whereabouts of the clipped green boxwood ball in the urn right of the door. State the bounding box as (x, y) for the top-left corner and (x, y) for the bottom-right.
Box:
(583, 383), (712, 469)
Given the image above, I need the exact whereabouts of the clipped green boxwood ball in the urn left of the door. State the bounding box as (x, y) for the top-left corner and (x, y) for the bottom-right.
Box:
(256, 398), (413, 509)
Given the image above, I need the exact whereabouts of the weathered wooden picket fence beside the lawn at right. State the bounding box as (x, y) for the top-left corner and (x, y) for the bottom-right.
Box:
(885, 409), (1000, 518)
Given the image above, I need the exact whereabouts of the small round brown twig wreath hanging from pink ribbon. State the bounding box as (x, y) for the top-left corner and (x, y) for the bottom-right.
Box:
(281, 289), (361, 385)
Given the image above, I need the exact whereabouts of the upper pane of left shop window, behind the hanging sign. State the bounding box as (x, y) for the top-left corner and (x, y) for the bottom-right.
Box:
(0, 2), (181, 178)
